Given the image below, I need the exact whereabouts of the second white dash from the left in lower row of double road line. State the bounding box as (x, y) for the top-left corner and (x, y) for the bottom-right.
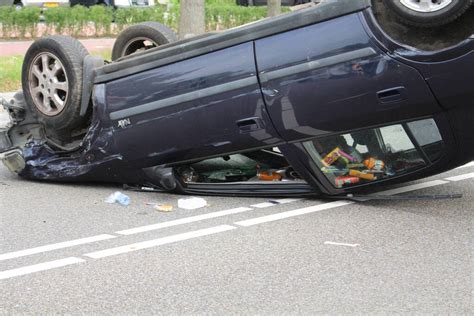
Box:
(84, 225), (236, 259)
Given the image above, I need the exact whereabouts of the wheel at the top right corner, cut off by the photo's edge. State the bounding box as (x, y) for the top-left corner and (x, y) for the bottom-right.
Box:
(384, 0), (472, 27)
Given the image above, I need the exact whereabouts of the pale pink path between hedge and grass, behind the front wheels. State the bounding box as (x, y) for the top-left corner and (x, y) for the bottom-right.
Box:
(0, 38), (115, 56)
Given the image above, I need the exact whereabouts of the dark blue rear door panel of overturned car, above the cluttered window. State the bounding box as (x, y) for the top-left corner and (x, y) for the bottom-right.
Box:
(255, 14), (440, 142)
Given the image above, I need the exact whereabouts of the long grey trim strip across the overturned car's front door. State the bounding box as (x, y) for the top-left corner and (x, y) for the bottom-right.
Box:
(109, 76), (258, 120)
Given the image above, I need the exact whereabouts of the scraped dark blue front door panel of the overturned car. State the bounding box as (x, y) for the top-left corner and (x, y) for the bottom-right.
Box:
(106, 42), (281, 165)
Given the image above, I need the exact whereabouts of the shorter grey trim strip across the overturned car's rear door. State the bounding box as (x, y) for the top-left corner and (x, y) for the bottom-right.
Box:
(259, 47), (376, 83)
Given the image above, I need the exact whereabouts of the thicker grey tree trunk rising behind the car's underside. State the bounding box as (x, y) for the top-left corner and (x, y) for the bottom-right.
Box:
(179, 0), (205, 39)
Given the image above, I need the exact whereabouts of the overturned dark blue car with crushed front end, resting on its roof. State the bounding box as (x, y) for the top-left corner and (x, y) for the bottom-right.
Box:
(0, 0), (474, 196)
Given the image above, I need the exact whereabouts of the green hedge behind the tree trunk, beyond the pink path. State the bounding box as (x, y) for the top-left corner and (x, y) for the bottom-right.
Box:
(0, 3), (274, 38)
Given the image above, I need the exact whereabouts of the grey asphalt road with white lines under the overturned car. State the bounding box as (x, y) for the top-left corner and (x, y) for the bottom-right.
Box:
(0, 149), (474, 314)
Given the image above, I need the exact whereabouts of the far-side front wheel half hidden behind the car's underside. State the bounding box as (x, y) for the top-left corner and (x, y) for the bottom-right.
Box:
(112, 22), (178, 60)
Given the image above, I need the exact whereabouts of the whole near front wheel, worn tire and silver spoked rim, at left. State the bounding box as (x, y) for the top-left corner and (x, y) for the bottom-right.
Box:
(22, 35), (88, 140)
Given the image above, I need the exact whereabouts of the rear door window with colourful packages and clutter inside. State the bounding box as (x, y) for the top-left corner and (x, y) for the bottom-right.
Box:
(303, 124), (436, 188)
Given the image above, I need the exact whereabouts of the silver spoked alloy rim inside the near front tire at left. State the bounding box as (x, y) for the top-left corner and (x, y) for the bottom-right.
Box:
(28, 53), (69, 116)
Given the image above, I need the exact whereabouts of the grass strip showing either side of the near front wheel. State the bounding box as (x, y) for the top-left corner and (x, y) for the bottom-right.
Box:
(0, 50), (112, 92)
